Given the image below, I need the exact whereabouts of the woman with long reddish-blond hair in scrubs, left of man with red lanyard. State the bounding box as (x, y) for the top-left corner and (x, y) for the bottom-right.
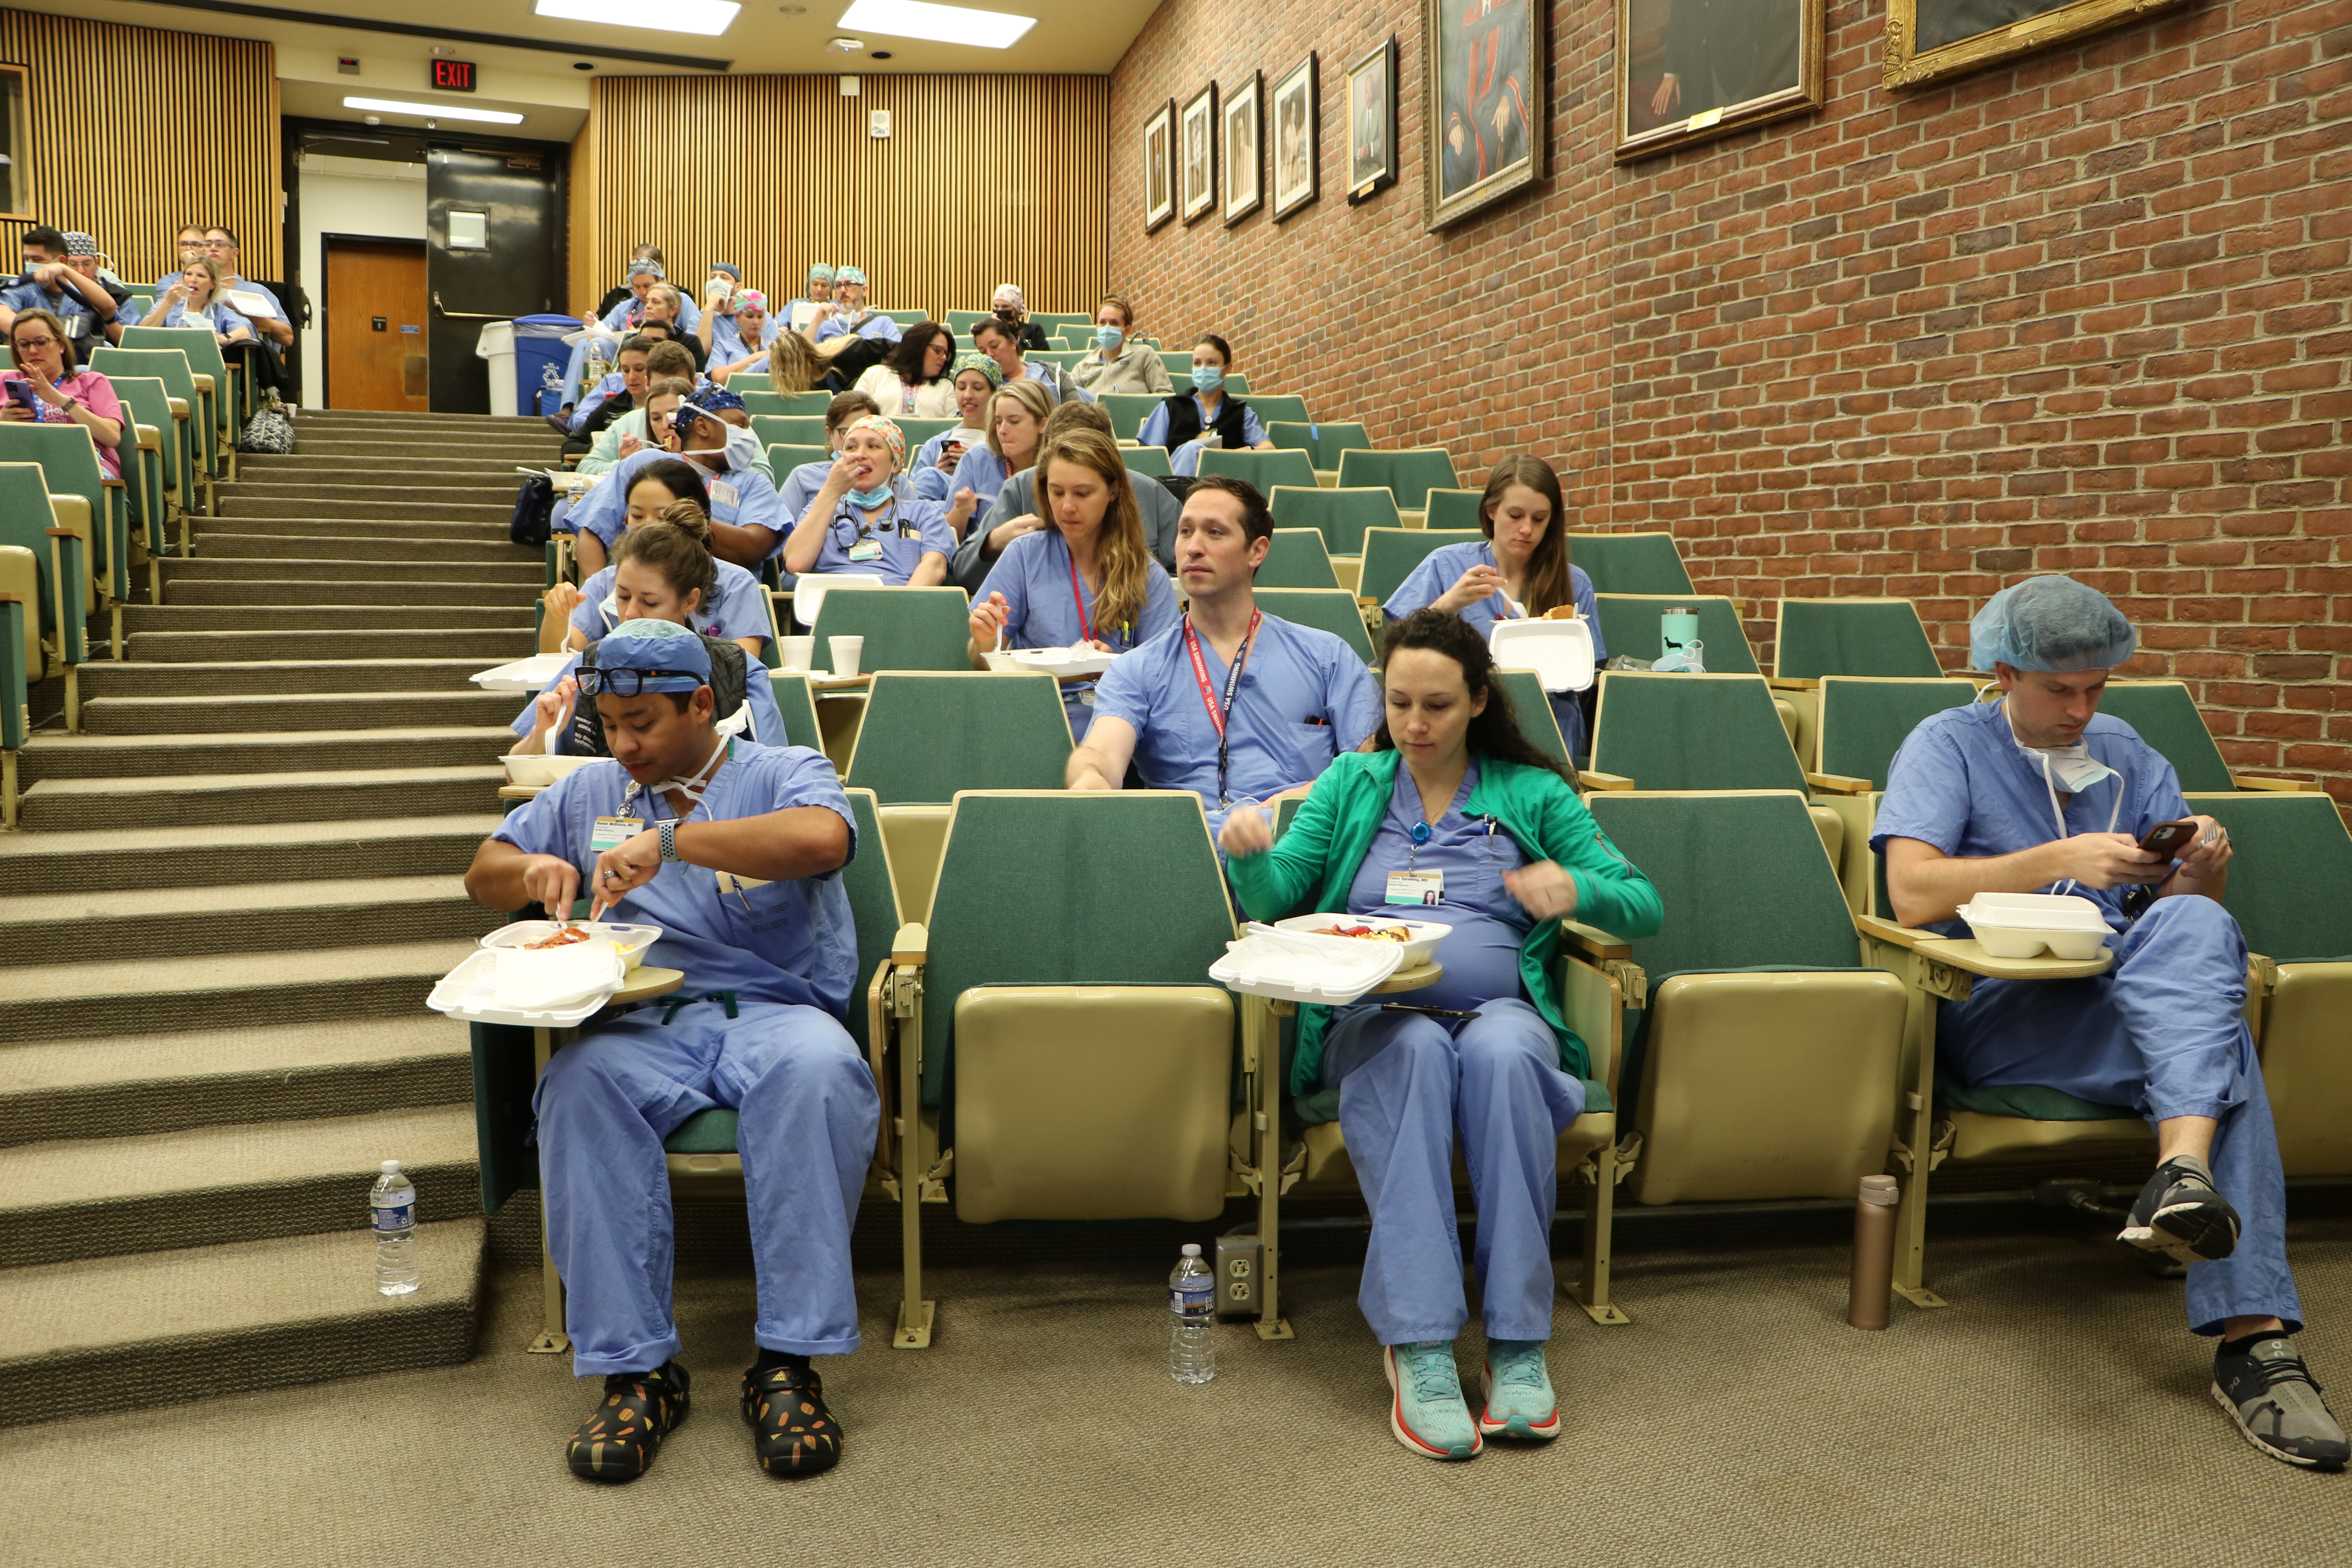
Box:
(971, 430), (1181, 740)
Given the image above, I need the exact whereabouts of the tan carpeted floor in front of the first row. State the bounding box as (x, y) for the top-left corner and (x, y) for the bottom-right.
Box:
(0, 1218), (2352, 1568)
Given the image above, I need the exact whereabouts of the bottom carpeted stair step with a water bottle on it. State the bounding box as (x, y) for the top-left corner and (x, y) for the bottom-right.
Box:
(0, 1222), (487, 1427)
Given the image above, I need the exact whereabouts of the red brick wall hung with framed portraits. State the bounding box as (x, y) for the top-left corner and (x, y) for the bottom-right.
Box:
(1110, 0), (2352, 804)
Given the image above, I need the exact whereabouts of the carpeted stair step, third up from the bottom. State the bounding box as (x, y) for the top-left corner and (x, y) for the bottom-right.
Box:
(0, 1013), (473, 1147)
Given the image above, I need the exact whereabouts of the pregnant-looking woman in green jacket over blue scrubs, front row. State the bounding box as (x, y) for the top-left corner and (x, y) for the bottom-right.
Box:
(1218, 609), (1661, 1460)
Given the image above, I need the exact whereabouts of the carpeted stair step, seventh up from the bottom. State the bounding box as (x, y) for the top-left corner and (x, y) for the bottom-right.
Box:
(19, 766), (506, 832)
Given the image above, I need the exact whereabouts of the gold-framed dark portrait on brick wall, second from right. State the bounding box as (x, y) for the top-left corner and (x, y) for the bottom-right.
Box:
(1616, 0), (1825, 160)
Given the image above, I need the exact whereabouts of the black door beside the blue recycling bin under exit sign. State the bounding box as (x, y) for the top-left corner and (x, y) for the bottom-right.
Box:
(426, 148), (564, 414)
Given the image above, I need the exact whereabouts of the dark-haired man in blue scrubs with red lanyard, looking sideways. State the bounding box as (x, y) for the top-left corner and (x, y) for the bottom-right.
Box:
(1065, 477), (1381, 835)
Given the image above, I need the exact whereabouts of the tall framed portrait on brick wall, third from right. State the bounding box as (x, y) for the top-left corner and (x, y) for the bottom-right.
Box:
(1421, 0), (1550, 228)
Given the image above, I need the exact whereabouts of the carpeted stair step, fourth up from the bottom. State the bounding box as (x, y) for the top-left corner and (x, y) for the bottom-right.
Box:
(0, 940), (473, 1048)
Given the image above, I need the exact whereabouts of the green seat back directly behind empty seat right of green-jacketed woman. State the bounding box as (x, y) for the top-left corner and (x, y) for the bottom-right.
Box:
(1592, 670), (1818, 799)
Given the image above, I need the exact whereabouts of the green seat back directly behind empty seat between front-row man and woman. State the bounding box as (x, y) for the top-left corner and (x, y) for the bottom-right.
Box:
(826, 668), (1070, 806)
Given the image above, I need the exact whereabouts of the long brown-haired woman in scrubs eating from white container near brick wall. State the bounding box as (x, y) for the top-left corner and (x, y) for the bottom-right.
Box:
(1381, 456), (1609, 757)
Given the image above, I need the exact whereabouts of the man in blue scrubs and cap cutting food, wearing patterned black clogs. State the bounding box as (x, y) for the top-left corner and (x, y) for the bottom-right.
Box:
(466, 621), (882, 1481)
